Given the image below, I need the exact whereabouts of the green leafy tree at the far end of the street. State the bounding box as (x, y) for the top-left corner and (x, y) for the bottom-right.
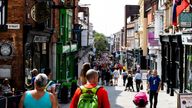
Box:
(94, 32), (108, 52)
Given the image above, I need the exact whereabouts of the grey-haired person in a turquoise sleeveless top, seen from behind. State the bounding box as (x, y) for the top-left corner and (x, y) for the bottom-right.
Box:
(19, 73), (57, 108)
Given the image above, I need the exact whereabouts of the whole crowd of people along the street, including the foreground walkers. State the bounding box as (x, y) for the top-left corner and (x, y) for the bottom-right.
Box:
(15, 54), (161, 108)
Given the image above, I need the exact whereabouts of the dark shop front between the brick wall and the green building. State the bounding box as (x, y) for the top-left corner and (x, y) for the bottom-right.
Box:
(24, 30), (52, 85)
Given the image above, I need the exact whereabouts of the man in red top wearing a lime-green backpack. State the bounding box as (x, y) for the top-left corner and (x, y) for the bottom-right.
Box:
(70, 69), (110, 108)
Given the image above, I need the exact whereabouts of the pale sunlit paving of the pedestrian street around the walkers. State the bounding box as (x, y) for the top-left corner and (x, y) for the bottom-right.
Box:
(61, 73), (177, 108)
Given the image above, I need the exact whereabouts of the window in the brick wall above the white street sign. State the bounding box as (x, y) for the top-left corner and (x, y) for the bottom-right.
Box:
(0, 0), (8, 31)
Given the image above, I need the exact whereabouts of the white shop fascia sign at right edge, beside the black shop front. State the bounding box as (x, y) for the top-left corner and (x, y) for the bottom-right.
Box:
(182, 34), (192, 45)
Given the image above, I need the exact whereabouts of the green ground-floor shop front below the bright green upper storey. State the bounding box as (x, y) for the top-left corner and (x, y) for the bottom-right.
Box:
(56, 43), (78, 81)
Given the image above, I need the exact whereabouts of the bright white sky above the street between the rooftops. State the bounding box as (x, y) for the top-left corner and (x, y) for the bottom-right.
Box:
(79, 0), (139, 36)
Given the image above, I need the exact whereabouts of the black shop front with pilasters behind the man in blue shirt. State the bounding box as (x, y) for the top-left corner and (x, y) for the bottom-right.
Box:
(160, 35), (183, 96)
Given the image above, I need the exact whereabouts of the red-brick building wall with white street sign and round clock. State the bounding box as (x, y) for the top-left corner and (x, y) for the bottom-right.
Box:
(0, 0), (25, 89)
